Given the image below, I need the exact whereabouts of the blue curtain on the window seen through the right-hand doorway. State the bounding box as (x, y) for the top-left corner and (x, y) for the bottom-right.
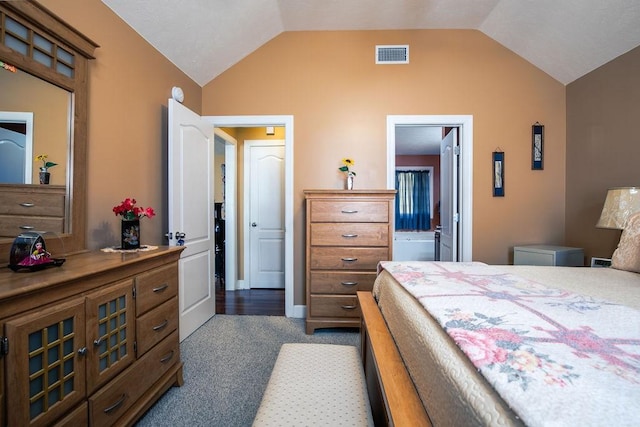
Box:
(396, 170), (431, 231)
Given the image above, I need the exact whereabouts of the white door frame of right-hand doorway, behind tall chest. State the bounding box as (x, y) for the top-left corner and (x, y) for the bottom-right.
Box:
(387, 115), (473, 261)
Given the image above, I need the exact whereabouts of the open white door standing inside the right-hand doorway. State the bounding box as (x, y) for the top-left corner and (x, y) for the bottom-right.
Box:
(440, 128), (459, 261)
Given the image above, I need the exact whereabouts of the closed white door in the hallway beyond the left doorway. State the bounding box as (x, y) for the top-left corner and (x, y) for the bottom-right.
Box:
(245, 140), (285, 289)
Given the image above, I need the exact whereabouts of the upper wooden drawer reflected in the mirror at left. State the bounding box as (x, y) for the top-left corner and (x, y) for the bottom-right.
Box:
(0, 192), (64, 216)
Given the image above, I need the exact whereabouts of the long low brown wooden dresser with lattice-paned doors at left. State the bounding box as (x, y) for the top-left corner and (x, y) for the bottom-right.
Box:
(0, 247), (184, 426)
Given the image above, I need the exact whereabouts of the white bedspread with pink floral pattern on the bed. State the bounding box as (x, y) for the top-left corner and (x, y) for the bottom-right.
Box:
(380, 262), (640, 426)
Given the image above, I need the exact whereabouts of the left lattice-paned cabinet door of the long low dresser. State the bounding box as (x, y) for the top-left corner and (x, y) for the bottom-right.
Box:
(5, 298), (86, 426)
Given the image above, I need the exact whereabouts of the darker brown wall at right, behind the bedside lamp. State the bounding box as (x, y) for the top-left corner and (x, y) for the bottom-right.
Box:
(566, 48), (640, 260)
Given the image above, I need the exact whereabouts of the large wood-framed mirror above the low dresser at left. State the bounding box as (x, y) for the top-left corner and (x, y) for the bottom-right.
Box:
(0, 0), (98, 262)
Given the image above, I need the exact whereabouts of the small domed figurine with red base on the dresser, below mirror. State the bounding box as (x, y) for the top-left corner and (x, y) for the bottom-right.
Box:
(9, 231), (65, 271)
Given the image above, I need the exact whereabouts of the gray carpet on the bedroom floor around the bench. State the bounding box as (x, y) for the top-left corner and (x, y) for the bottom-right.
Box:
(137, 314), (360, 427)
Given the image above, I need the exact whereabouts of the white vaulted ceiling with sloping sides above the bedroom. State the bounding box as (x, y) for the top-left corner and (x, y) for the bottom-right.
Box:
(102, 0), (640, 86)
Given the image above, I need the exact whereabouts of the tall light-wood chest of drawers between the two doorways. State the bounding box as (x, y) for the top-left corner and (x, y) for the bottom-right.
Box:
(304, 190), (396, 334)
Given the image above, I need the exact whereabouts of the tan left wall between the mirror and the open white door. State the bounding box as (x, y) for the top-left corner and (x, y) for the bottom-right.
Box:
(40, 0), (202, 249)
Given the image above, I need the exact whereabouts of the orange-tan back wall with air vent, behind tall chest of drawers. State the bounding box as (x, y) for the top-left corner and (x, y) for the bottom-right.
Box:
(202, 30), (566, 304)
